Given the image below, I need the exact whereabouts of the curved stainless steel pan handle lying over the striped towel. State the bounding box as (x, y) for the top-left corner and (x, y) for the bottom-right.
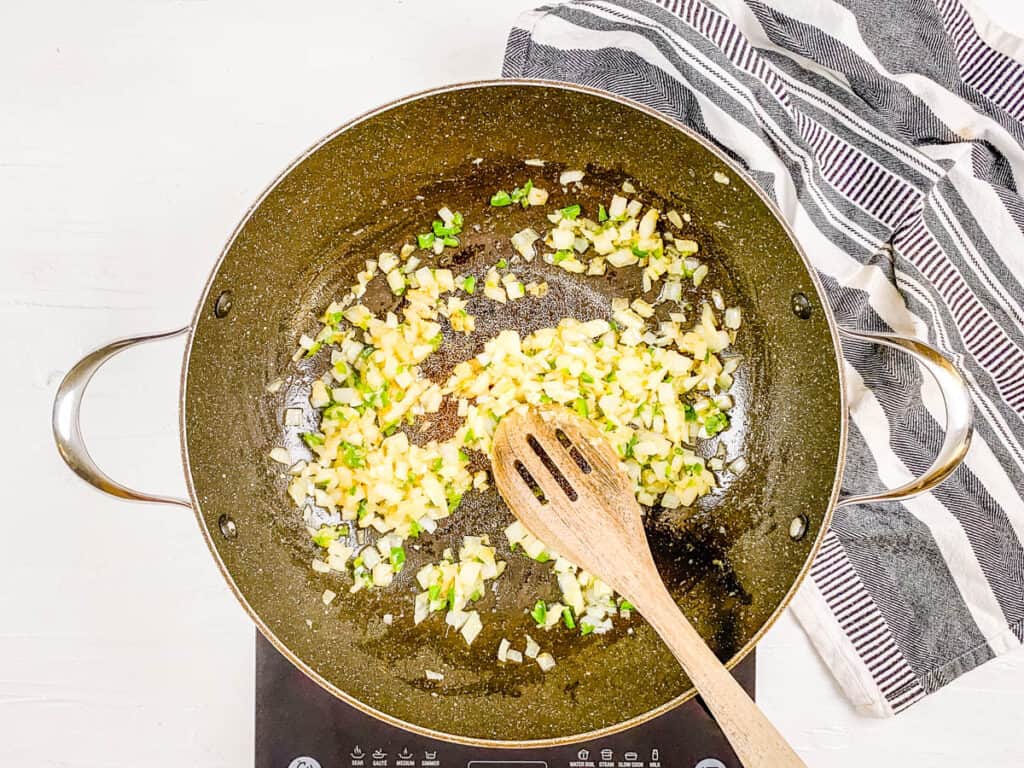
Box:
(836, 328), (974, 509)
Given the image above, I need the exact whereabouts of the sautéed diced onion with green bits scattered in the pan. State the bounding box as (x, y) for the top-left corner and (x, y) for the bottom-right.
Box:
(282, 177), (745, 659)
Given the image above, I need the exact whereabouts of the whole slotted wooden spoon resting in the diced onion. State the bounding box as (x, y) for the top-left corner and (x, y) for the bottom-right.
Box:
(494, 408), (804, 768)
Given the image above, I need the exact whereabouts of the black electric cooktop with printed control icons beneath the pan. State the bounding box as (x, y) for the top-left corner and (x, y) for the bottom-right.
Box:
(255, 634), (754, 768)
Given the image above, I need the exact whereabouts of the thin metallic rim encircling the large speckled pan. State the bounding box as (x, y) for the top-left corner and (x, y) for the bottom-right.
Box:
(178, 78), (849, 749)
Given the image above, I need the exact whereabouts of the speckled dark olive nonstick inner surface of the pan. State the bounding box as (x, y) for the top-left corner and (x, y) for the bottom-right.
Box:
(182, 82), (845, 743)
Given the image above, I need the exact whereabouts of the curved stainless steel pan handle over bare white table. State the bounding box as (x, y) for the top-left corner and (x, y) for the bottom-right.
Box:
(53, 326), (191, 509)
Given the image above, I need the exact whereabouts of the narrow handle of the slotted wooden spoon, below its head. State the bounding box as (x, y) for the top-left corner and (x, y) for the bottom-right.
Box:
(631, 579), (806, 768)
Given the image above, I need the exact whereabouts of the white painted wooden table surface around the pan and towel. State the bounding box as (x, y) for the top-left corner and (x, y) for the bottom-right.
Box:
(0, 0), (1024, 768)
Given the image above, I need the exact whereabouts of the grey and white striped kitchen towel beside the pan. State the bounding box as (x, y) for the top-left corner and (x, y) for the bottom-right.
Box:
(503, 0), (1024, 716)
